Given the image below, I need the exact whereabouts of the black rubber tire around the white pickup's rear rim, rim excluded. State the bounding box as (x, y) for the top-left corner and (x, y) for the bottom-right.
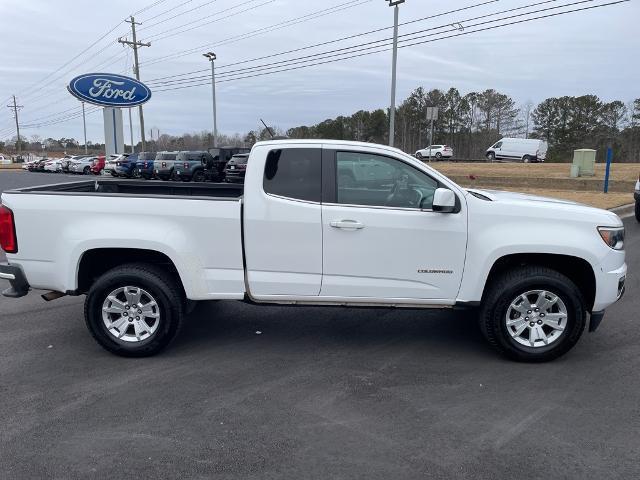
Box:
(84, 263), (186, 357)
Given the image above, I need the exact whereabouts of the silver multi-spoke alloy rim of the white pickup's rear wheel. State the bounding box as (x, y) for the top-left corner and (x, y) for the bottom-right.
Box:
(102, 287), (160, 342)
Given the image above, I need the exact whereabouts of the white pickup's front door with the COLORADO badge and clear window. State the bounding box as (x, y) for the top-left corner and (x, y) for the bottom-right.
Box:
(320, 145), (467, 303)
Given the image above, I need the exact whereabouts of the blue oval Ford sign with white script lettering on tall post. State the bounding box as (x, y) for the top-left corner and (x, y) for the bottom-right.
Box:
(67, 73), (151, 107)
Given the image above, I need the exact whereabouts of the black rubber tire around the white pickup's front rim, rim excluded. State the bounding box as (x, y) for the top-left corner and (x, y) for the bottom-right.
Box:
(480, 265), (586, 362)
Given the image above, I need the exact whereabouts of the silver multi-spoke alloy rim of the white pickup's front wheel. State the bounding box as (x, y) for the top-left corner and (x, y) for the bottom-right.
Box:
(505, 290), (568, 348)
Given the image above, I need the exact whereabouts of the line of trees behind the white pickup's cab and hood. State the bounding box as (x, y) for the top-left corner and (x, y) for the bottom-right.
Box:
(286, 87), (640, 162)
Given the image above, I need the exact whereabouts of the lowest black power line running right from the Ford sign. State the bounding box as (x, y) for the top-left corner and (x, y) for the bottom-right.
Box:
(154, 0), (630, 93)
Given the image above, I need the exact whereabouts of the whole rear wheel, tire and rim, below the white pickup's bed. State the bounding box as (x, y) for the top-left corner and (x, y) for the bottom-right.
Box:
(84, 264), (184, 357)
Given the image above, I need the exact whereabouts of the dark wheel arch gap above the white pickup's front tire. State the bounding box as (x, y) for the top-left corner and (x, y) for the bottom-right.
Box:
(482, 253), (596, 312)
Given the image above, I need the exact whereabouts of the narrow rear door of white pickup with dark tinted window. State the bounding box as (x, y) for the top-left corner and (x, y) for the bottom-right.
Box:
(244, 144), (322, 299)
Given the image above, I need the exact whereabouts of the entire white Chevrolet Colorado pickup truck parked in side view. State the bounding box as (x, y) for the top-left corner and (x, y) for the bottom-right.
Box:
(0, 140), (627, 361)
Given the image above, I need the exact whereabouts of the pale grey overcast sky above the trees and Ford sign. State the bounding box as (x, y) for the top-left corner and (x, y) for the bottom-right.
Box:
(0, 0), (640, 142)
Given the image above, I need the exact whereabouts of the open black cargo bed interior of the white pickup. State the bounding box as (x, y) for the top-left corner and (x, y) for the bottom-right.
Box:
(6, 178), (244, 199)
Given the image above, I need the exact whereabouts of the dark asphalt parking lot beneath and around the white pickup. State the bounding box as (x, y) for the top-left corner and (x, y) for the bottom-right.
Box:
(0, 172), (640, 479)
